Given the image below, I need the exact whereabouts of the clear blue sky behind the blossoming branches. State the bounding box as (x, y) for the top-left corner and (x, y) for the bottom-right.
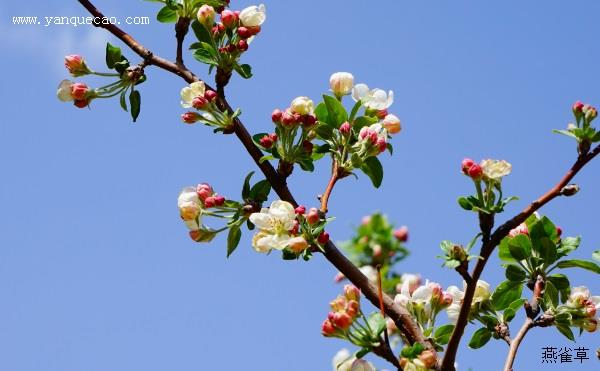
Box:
(0, 0), (600, 371)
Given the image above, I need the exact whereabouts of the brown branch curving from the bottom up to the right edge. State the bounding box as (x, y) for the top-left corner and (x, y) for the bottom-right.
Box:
(442, 146), (600, 370)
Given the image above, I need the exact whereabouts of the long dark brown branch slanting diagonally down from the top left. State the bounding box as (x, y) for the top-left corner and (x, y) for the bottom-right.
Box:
(78, 0), (432, 366)
